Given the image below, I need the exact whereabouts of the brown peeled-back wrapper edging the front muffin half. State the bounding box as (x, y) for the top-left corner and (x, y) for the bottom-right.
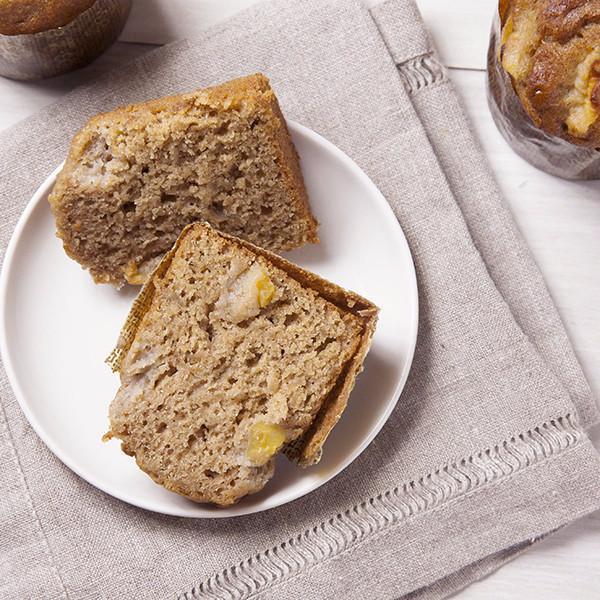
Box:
(107, 223), (379, 466)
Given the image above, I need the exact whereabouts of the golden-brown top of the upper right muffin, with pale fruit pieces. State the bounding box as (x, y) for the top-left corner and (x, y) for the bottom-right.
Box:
(500, 0), (600, 148)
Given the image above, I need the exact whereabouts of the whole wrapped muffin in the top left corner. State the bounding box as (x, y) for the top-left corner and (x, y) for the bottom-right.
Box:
(0, 0), (131, 80)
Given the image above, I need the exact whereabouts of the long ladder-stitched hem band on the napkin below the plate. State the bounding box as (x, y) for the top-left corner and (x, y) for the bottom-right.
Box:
(179, 414), (585, 600)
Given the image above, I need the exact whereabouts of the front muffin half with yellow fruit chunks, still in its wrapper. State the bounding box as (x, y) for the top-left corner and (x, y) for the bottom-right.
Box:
(107, 223), (377, 505)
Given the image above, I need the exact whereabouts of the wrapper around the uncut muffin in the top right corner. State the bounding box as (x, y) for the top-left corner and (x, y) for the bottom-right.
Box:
(487, 8), (600, 179)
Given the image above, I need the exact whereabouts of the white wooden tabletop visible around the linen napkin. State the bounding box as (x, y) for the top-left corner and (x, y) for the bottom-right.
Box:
(0, 0), (600, 600)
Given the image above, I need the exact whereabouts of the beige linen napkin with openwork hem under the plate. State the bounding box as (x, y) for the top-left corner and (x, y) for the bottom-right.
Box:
(0, 0), (600, 599)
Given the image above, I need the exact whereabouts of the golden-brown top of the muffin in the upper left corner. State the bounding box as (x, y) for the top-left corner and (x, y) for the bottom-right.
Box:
(0, 0), (96, 35)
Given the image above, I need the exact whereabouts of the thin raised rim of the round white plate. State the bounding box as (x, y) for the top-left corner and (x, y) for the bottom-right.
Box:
(0, 119), (419, 519)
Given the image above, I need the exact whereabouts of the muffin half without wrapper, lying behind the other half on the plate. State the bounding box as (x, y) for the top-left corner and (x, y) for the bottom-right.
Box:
(49, 74), (318, 286)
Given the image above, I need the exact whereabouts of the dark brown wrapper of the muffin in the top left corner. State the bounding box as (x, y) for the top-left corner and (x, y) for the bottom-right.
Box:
(0, 0), (132, 80)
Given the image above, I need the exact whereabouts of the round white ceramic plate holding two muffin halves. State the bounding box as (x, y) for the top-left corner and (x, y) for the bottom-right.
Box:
(0, 123), (418, 517)
